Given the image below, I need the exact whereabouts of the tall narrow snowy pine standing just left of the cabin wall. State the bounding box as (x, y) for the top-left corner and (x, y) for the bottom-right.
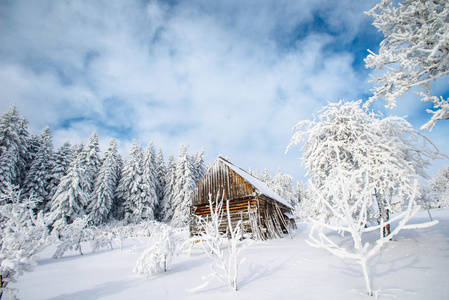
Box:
(171, 144), (196, 227)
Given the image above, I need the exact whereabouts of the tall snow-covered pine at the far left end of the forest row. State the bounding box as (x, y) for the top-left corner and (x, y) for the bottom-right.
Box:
(0, 104), (28, 192)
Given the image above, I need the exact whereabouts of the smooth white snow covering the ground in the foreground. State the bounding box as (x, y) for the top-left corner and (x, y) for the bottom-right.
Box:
(13, 209), (449, 300)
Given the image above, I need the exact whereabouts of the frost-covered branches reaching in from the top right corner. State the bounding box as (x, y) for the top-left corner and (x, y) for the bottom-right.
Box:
(365, 0), (449, 130)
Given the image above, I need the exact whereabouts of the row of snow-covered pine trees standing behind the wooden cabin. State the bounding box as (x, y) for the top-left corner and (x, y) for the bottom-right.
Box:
(0, 105), (302, 227)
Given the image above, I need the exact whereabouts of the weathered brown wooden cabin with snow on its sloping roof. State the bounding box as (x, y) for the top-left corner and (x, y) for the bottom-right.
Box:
(190, 157), (296, 240)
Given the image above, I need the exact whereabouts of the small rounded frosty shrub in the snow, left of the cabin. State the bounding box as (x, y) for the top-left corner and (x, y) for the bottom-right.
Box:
(134, 223), (178, 276)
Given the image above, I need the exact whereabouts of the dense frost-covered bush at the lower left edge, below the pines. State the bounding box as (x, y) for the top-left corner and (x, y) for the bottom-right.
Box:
(0, 187), (53, 299)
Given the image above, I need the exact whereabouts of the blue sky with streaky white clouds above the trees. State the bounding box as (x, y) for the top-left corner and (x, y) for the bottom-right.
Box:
(0, 0), (449, 180)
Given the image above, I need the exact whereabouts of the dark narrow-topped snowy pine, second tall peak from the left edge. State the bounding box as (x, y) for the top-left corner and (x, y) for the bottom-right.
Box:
(23, 126), (54, 213)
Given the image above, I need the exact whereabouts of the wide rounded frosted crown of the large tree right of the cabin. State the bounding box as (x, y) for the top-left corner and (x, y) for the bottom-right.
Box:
(289, 101), (439, 235)
